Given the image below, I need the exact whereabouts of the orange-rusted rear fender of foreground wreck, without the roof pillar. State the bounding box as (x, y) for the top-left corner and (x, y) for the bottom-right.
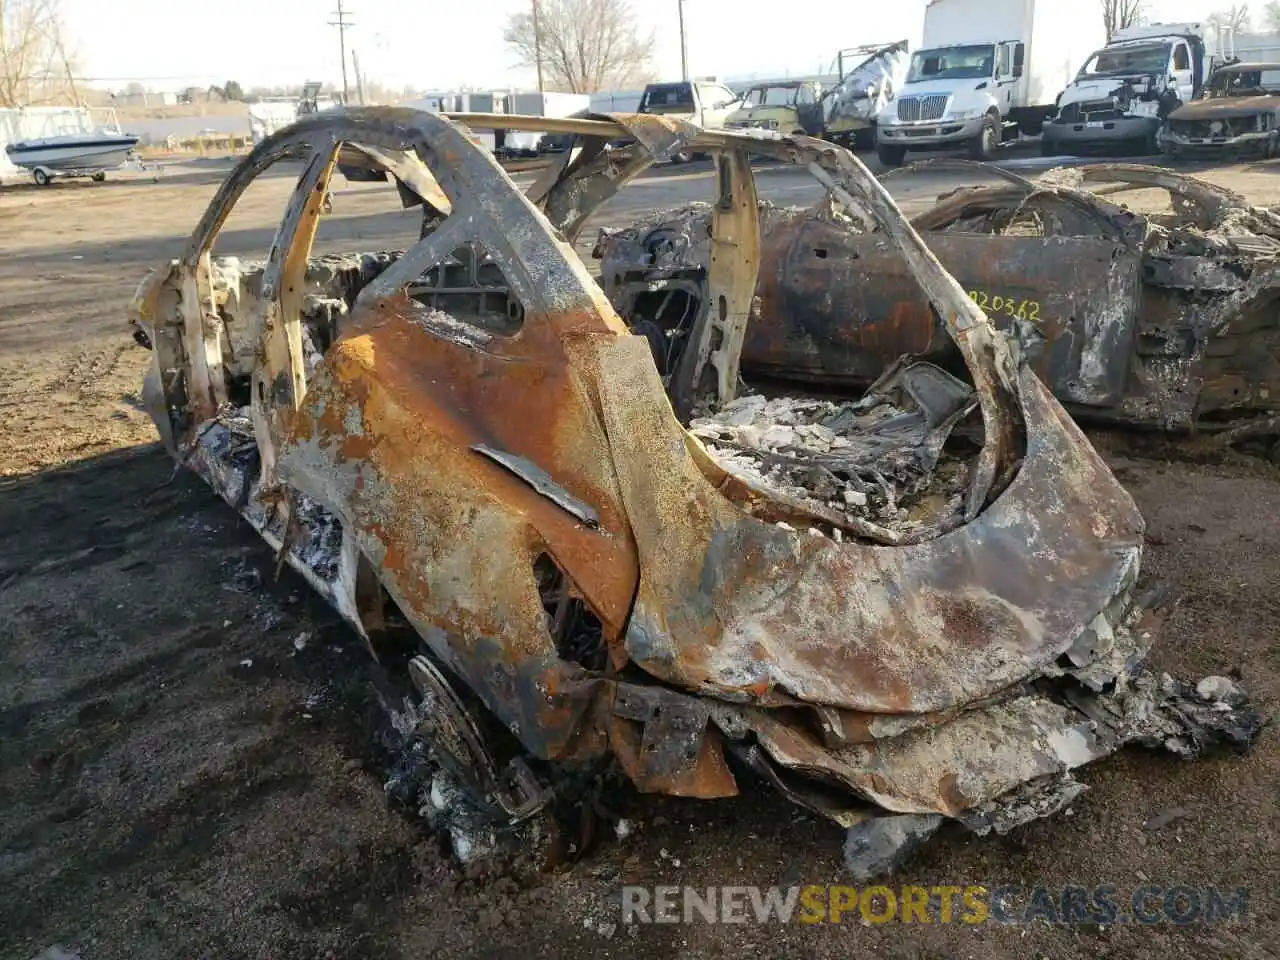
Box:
(280, 298), (637, 758)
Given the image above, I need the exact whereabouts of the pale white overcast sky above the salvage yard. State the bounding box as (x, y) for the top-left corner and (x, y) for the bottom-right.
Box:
(63, 0), (1230, 90)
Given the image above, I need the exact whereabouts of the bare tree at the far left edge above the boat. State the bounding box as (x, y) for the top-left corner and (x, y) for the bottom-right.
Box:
(0, 0), (78, 108)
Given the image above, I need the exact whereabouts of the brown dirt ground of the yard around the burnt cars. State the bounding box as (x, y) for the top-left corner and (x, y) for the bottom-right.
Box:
(0, 154), (1280, 960)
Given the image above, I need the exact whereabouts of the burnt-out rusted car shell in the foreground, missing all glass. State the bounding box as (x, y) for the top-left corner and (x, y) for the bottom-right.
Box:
(133, 108), (1252, 872)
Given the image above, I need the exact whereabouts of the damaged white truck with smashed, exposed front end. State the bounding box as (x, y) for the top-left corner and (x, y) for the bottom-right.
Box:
(1041, 23), (1215, 156)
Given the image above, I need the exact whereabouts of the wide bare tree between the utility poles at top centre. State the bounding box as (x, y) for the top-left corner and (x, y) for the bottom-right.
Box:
(502, 0), (654, 93)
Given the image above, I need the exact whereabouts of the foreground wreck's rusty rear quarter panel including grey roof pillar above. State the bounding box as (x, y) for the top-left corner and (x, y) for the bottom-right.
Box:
(263, 110), (650, 759)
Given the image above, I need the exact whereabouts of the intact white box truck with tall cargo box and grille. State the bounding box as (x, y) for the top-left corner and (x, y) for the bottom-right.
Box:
(876, 0), (1106, 166)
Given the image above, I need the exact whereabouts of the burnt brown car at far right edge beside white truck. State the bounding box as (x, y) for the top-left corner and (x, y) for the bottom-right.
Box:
(1158, 63), (1280, 159)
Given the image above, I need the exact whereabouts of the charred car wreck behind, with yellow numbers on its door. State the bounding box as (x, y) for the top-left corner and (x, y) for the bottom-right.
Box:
(595, 160), (1280, 442)
